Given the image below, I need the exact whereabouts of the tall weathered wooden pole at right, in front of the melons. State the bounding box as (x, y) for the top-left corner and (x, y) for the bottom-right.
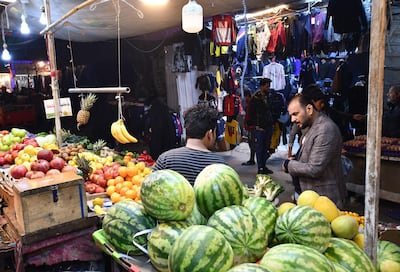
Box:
(364, 0), (387, 264)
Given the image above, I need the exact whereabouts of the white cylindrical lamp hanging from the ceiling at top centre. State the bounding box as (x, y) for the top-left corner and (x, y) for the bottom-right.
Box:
(182, 0), (203, 33)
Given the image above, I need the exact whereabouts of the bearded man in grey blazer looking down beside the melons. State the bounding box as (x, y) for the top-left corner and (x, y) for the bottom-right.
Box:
(282, 94), (346, 208)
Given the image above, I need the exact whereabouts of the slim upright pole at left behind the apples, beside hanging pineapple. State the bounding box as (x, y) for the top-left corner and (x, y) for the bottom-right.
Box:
(45, 0), (62, 146)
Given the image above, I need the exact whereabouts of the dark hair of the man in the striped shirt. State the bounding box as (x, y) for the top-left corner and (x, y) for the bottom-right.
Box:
(183, 104), (218, 139)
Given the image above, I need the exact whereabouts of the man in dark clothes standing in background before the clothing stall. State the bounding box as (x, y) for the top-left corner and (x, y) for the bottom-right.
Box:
(249, 78), (274, 174)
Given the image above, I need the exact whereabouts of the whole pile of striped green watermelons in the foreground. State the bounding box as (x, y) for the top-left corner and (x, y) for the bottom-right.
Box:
(93, 164), (400, 272)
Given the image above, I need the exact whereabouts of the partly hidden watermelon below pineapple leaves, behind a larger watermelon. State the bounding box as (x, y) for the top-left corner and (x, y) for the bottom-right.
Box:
(243, 196), (278, 242)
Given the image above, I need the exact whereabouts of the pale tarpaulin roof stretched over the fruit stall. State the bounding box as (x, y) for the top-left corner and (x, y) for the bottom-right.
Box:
(0, 0), (312, 42)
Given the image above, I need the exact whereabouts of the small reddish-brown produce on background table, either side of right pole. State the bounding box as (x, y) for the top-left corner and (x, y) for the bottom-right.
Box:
(343, 135), (400, 157)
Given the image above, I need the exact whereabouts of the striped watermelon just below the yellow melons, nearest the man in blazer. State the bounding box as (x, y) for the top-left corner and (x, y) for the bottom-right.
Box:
(275, 206), (331, 253)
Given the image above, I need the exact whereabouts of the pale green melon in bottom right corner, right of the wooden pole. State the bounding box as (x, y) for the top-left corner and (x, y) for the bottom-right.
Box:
(376, 241), (400, 272)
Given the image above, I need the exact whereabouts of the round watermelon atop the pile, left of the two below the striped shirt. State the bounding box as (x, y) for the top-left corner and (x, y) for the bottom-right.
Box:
(140, 169), (195, 221)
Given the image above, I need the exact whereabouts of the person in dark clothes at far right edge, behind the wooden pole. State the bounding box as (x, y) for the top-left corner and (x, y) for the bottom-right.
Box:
(382, 86), (400, 138)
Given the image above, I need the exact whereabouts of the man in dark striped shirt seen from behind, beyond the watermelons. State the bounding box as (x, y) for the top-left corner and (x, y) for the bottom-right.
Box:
(153, 104), (225, 185)
